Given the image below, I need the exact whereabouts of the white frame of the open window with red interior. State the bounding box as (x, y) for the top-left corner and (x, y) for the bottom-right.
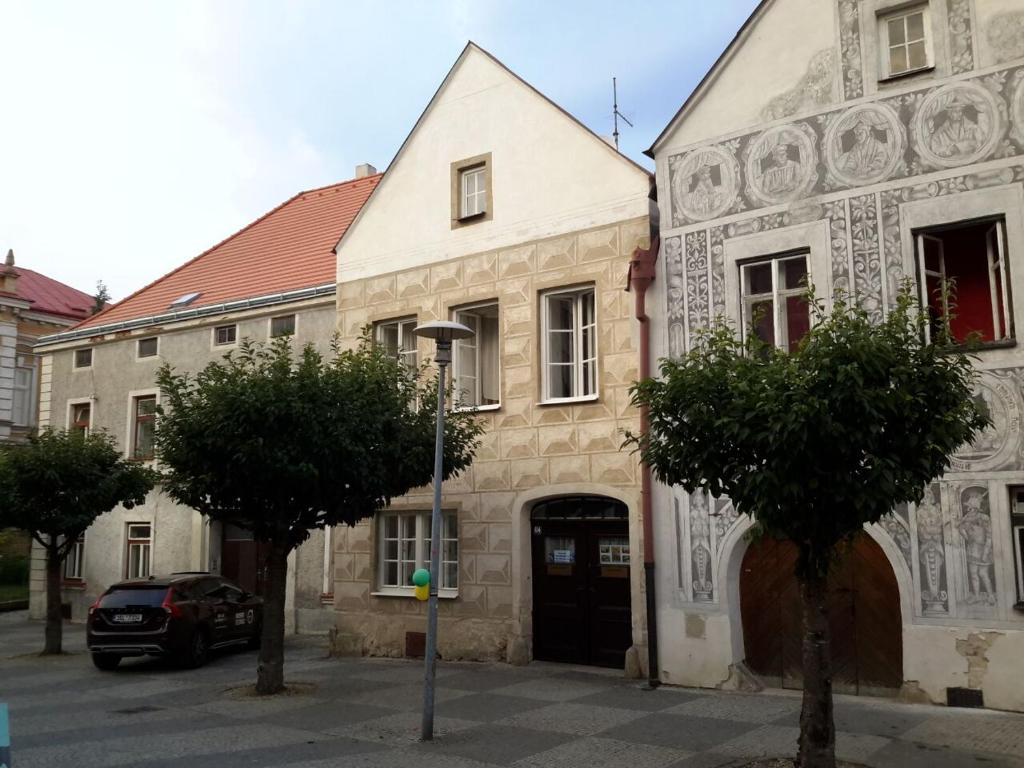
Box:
(914, 217), (1015, 344)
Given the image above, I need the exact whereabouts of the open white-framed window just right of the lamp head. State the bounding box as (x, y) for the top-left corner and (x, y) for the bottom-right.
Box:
(452, 301), (501, 408)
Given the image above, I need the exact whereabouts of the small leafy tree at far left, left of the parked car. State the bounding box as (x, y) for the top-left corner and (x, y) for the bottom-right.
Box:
(0, 429), (159, 653)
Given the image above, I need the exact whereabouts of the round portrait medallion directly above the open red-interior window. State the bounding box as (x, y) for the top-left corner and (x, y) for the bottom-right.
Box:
(913, 83), (1005, 168)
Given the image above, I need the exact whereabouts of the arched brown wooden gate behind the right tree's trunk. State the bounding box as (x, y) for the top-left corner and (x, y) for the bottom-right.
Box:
(739, 532), (903, 695)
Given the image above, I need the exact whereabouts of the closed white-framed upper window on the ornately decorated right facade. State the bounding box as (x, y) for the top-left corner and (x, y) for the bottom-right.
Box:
(739, 253), (811, 352)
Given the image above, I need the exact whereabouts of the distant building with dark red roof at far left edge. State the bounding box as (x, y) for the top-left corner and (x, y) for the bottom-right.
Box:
(0, 250), (95, 442)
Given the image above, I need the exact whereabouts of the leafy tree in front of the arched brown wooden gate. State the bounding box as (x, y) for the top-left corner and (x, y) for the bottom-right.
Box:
(630, 290), (988, 768)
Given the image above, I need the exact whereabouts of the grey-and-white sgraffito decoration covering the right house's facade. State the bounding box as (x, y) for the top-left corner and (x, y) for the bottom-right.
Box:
(663, 46), (1024, 626)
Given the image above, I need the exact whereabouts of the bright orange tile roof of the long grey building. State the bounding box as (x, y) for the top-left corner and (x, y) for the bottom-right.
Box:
(76, 174), (381, 328)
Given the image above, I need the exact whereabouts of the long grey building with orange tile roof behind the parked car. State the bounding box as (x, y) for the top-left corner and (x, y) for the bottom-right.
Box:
(30, 165), (381, 631)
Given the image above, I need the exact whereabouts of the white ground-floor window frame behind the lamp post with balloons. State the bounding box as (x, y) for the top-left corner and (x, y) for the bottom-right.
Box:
(374, 510), (459, 598)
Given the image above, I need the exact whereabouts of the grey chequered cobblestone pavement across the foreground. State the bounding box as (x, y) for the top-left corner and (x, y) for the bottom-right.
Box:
(0, 613), (1024, 768)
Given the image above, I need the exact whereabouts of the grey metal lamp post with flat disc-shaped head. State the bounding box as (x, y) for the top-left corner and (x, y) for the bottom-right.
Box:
(413, 321), (473, 741)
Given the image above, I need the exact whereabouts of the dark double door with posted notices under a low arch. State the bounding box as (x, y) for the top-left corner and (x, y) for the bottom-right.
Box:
(530, 496), (633, 669)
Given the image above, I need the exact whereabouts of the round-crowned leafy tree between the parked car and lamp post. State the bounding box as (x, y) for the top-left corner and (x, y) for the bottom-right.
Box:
(157, 335), (480, 693)
